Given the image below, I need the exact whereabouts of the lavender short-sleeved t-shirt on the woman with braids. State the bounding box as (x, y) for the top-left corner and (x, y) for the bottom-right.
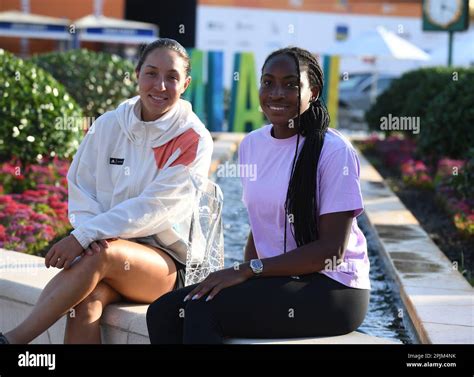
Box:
(239, 124), (370, 289)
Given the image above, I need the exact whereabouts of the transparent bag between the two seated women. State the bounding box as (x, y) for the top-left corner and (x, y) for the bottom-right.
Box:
(185, 175), (224, 286)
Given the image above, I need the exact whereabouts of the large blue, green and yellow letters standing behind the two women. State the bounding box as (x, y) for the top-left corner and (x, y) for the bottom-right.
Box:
(183, 49), (339, 132)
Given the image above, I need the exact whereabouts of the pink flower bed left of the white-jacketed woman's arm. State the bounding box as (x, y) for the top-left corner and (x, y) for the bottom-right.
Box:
(0, 159), (70, 254)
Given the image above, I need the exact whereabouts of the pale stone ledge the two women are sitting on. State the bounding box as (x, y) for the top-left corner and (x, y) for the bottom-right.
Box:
(0, 249), (394, 344)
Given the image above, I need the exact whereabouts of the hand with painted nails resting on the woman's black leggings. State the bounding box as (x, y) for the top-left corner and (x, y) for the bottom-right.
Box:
(184, 264), (253, 301)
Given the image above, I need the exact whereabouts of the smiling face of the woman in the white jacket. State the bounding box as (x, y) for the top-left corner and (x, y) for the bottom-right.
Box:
(136, 48), (191, 122)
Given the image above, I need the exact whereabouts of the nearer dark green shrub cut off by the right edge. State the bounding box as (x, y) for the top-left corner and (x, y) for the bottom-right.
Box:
(417, 69), (474, 161)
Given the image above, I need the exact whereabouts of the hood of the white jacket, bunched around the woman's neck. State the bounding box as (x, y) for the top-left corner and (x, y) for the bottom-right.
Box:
(115, 96), (196, 148)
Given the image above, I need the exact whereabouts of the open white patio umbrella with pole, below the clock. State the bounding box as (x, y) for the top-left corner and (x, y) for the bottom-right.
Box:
(325, 26), (430, 101)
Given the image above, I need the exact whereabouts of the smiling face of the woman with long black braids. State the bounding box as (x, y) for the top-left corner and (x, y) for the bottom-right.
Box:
(259, 54), (318, 133)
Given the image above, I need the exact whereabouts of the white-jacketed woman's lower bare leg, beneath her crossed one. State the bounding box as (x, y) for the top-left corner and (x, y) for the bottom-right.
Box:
(64, 281), (121, 344)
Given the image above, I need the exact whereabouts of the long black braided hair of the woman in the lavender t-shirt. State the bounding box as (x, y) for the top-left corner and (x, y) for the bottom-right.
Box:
(262, 47), (329, 252)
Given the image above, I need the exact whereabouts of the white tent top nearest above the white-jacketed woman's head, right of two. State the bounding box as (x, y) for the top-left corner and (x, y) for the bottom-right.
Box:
(72, 15), (158, 47)
